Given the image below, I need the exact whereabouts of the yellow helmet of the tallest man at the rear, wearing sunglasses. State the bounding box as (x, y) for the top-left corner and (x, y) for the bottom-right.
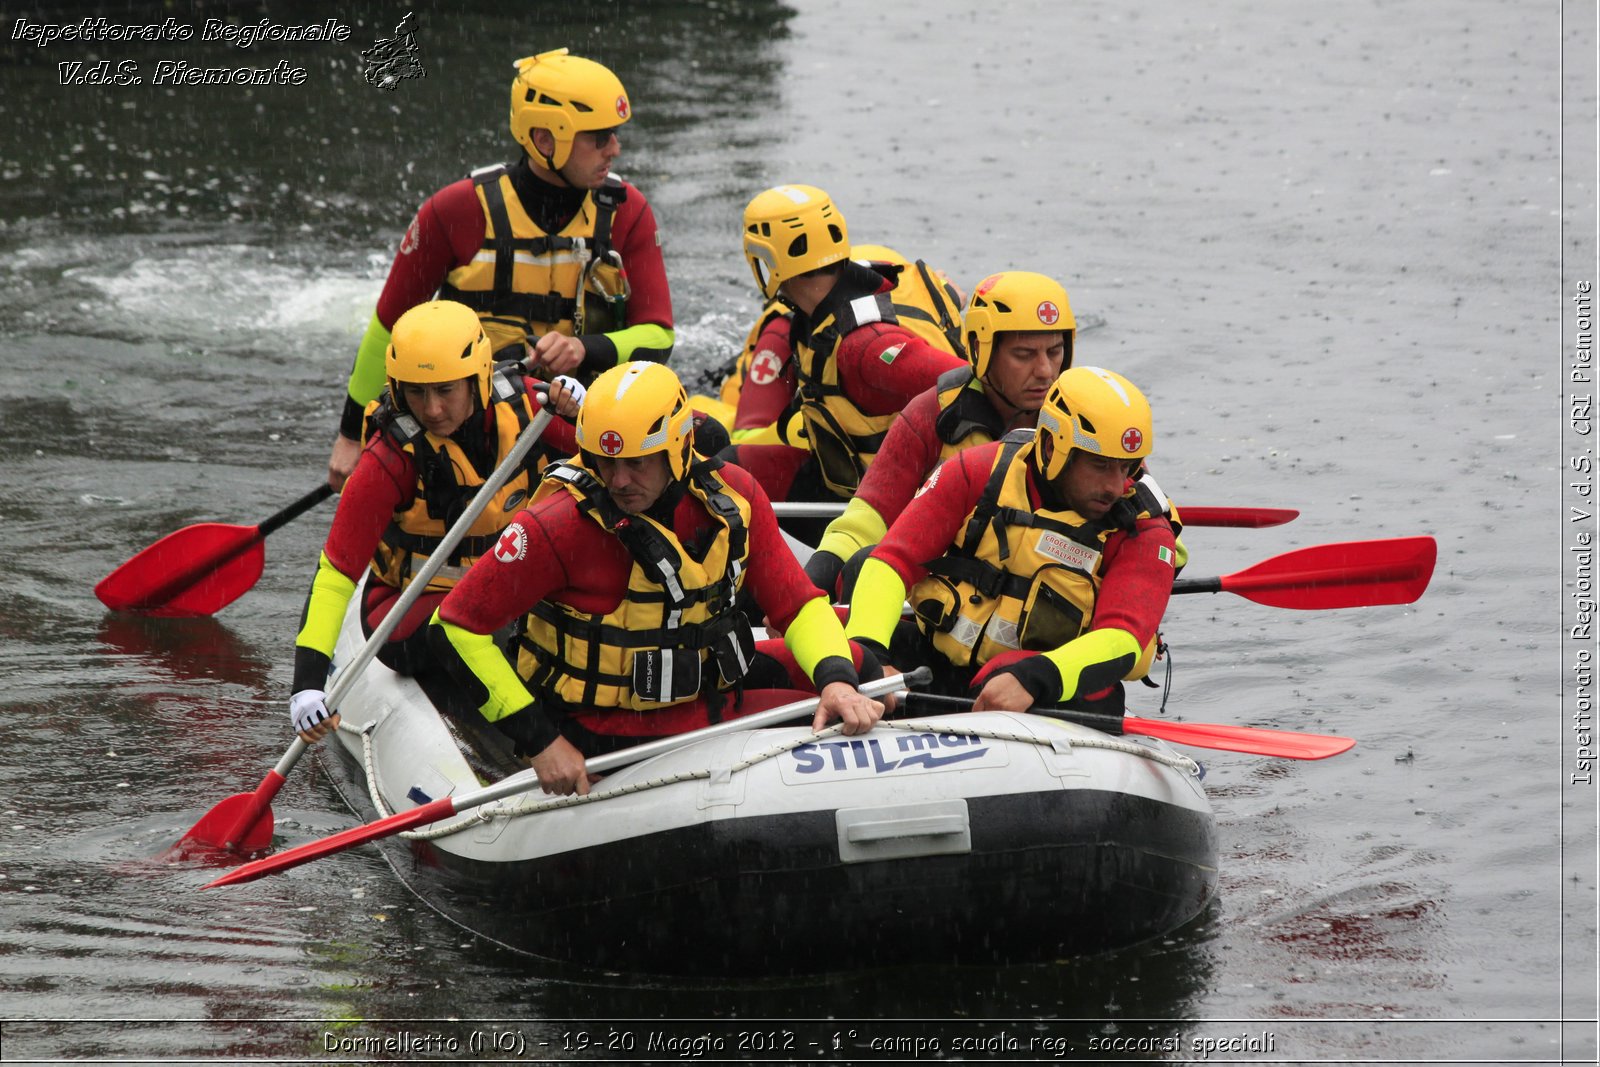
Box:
(510, 48), (634, 171)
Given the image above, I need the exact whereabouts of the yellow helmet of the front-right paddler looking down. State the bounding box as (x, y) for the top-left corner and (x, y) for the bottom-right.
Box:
(1034, 366), (1155, 480)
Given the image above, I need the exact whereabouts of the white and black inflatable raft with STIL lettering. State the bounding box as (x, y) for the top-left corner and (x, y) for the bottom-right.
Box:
(321, 600), (1216, 976)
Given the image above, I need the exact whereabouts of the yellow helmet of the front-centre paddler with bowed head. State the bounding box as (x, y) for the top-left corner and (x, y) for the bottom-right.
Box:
(578, 362), (694, 478)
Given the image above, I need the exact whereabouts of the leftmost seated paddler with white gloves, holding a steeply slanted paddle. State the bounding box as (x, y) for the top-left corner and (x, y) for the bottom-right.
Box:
(290, 301), (582, 741)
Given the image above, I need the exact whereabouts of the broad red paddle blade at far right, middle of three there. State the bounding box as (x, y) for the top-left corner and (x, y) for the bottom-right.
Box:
(1221, 537), (1438, 611)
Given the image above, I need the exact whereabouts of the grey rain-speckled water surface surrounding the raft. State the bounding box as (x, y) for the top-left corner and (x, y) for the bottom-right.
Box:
(0, 0), (1597, 1062)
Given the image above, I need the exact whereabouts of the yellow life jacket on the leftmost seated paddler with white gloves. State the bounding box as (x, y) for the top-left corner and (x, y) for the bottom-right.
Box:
(366, 370), (539, 589)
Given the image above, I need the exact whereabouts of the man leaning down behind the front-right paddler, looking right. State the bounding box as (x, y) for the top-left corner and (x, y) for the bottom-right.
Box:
(805, 270), (1077, 601)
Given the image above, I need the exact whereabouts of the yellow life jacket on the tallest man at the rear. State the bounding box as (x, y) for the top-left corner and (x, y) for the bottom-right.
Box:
(438, 163), (627, 352)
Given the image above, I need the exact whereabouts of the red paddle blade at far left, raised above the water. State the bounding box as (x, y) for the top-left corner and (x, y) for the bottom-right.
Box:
(94, 523), (266, 614)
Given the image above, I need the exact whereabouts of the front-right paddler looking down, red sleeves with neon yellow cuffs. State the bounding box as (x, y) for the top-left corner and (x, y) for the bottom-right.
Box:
(846, 366), (1179, 715)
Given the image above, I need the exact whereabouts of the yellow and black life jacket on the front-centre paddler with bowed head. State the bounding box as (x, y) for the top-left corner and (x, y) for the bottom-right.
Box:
(517, 461), (754, 710)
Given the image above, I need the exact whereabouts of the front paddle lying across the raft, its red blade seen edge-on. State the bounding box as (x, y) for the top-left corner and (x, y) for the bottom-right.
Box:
(202, 667), (931, 889)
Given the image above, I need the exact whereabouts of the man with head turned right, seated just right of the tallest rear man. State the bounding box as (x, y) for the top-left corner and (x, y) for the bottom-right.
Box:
(725, 186), (965, 518)
